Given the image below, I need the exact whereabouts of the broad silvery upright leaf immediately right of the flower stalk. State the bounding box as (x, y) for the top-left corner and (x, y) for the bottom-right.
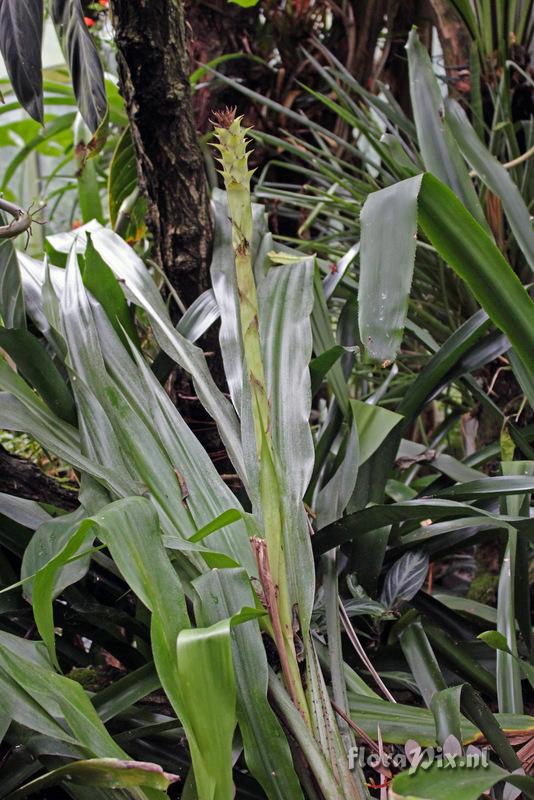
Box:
(256, 253), (314, 635)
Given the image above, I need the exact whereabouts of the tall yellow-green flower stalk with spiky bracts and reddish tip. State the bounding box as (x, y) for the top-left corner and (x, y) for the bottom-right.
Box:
(211, 110), (309, 722)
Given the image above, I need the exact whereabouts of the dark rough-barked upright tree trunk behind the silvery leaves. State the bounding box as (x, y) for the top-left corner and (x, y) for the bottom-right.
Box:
(111, 0), (211, 305)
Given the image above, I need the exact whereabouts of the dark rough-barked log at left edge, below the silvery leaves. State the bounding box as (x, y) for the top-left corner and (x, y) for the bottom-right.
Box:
(0, 445), (78, 511)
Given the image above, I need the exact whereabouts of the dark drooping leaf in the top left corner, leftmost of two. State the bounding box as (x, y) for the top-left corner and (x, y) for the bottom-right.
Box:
(0, 0), (44, 122)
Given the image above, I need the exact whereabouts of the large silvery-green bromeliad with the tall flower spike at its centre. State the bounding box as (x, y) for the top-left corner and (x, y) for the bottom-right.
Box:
(0, 108), (367, 800)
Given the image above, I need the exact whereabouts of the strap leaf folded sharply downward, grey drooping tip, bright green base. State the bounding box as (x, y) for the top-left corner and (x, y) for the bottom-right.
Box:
(359, 173), (534, 371)
